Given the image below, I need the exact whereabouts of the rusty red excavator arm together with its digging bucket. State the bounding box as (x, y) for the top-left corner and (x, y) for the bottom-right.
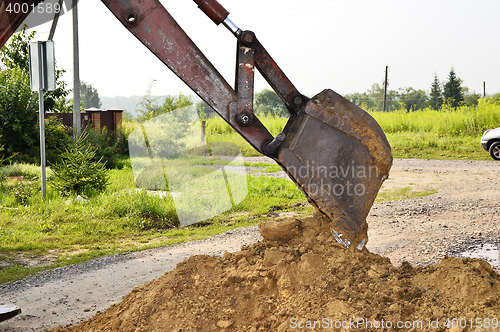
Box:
(0, 0), (392, 249)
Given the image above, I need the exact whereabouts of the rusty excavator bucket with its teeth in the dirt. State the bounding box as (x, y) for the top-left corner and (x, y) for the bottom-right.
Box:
(276, 90), (392, 249)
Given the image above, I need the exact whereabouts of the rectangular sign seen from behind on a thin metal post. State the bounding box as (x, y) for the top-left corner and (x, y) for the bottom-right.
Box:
(29, 41), (56, 199)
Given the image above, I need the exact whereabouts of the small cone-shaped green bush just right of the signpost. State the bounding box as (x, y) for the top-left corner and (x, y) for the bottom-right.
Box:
(50, 131), (109, 196)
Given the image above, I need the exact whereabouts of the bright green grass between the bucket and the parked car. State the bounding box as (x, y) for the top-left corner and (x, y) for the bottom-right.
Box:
(370, 98), (500, 160)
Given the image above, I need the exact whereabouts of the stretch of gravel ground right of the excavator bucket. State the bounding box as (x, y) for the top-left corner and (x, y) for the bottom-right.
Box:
(367, 159), (500, 268)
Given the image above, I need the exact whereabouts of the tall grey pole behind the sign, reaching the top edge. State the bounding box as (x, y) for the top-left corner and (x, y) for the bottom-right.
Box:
(73, 0), (82, 141)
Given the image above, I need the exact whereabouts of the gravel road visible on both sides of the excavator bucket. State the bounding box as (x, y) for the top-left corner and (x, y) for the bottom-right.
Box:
(0, 159), (500, 332)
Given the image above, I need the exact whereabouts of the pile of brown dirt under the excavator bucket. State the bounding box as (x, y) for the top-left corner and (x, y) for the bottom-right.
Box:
(50, 218), (500, 332)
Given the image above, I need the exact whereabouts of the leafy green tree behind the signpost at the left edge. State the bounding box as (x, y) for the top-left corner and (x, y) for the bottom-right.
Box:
(0, 26), (72, 163)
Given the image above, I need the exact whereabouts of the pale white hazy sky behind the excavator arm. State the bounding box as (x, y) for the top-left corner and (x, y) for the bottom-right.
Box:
(25, 0), (500, 97)
